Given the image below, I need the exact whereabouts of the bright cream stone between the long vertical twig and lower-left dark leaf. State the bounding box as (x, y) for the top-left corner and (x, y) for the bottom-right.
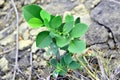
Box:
(19, 40), (33, 50)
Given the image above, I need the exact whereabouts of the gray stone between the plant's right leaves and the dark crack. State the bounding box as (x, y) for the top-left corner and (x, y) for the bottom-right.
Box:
(85, 22), (109, 45)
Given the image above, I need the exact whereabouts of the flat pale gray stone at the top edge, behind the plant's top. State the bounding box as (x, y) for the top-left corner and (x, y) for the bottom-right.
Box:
(42, 0), (79, 14)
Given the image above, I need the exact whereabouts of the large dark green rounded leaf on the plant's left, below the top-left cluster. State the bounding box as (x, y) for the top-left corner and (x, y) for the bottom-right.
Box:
(36, 31), (52, 48)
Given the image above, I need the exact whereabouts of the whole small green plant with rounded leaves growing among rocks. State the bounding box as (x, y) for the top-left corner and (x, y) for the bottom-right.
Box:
(23, 4), (88, 77)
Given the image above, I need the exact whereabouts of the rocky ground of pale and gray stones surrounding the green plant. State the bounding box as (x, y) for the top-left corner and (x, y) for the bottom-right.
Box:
(0, 0), (120, 80)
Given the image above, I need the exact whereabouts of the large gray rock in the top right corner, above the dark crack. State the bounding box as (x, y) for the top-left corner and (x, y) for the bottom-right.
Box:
(91, 0), (120, 48)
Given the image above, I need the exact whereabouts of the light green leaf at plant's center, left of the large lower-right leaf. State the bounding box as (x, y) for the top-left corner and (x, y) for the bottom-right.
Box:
(55, 36), (70, 47)
